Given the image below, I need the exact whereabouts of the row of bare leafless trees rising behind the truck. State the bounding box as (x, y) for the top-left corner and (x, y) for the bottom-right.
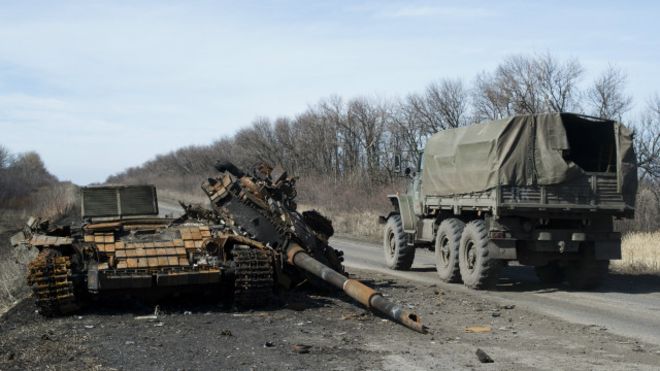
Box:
(108, 54), (660, 231)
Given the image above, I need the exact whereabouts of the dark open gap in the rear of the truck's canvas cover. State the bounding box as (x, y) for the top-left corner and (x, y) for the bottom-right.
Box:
(564, 116), (617, 173)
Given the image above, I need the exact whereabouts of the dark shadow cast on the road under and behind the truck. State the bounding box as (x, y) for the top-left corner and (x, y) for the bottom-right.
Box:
(496, 266), (660, 294)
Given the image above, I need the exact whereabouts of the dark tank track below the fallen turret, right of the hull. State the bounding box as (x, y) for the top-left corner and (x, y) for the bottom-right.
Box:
(233, 248), (275, 309)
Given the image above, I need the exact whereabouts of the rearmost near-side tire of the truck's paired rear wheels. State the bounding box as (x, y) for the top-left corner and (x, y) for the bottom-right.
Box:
(458, 220), (502, 290)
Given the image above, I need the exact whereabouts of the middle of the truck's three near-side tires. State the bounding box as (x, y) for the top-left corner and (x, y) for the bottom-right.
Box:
(435, 218), (465, 283)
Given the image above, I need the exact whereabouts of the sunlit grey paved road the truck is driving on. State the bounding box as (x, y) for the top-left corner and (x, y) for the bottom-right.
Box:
(331, 237), (660, 344)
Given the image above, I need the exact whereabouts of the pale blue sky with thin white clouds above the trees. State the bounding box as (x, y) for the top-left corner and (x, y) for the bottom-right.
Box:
(0, 0), (660, 185)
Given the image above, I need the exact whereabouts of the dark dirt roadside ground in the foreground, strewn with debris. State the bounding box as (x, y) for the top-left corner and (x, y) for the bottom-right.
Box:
(0, 270), (660, 370)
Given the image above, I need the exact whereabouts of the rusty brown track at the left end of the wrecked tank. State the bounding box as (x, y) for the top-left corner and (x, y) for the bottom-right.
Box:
(27, 249), (80, 317)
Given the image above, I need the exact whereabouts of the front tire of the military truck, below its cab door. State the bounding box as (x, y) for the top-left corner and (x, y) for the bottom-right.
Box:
(383, 214), (415, 270)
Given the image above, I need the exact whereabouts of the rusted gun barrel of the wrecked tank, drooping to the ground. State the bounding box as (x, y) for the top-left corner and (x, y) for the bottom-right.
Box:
(287, 243), (428, 334)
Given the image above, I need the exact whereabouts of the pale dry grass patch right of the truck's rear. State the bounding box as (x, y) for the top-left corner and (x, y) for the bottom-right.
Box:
(612, 232), (660, 273)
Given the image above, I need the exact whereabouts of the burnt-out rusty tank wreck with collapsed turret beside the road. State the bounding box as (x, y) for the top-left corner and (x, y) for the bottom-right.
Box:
(12, 163), (426, 332)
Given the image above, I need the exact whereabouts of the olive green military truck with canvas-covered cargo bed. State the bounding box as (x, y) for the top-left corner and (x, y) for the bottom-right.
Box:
(380, 113), (637, 289)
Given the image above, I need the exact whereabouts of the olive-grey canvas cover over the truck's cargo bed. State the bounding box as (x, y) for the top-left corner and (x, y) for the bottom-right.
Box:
(421, 113), (637, 199)
